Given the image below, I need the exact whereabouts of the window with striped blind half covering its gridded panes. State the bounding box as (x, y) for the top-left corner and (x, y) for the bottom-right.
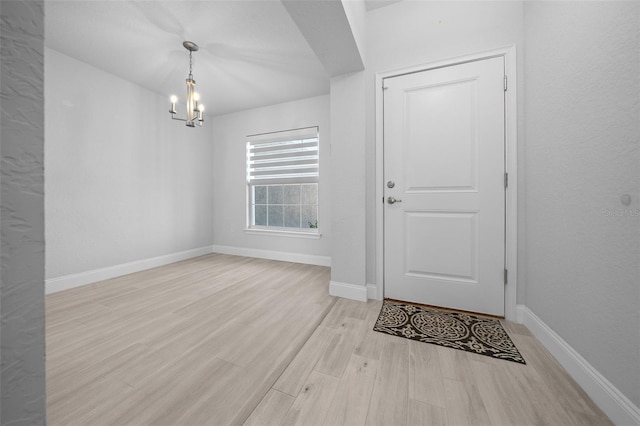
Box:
(247, 127), (319, 233)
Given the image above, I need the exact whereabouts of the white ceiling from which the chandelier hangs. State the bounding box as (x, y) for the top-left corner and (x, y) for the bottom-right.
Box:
(45, 0), (329, 116)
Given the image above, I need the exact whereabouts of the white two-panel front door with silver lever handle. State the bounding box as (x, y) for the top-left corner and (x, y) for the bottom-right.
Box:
(383, 57), (505, 316)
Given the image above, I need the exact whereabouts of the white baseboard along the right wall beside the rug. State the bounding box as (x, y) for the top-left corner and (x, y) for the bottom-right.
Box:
(516, 305), (640, 426)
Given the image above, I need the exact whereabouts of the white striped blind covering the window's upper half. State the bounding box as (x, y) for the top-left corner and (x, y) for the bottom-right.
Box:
(247, 127), (319, 185)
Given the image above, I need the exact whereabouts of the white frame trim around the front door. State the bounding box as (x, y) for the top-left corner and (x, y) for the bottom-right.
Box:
(375, 44), (518, 321)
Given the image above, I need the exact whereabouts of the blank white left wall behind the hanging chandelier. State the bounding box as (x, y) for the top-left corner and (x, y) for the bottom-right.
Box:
(45, 49), (213, 279)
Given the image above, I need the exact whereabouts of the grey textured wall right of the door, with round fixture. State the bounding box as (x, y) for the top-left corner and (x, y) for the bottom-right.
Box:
(525, 2), (640, 406)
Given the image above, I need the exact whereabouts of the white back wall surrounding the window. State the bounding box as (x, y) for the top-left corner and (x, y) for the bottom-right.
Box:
(212, 95), (332, 262)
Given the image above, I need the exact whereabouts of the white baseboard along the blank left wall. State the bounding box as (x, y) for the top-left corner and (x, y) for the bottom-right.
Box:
(45, 246), (213, 294)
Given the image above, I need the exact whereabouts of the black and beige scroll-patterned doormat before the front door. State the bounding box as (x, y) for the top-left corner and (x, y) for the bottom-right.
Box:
(373, 300), (526, 364)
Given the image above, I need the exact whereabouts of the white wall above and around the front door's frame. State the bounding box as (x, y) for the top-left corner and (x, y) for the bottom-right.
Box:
(366, 0), (526, 301)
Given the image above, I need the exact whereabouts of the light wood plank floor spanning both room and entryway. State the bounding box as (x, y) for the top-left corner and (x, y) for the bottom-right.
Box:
(47, 255), (611, 426)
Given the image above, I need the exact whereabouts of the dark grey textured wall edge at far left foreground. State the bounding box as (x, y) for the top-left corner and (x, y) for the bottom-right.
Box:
(0, 0), (46, 426)
